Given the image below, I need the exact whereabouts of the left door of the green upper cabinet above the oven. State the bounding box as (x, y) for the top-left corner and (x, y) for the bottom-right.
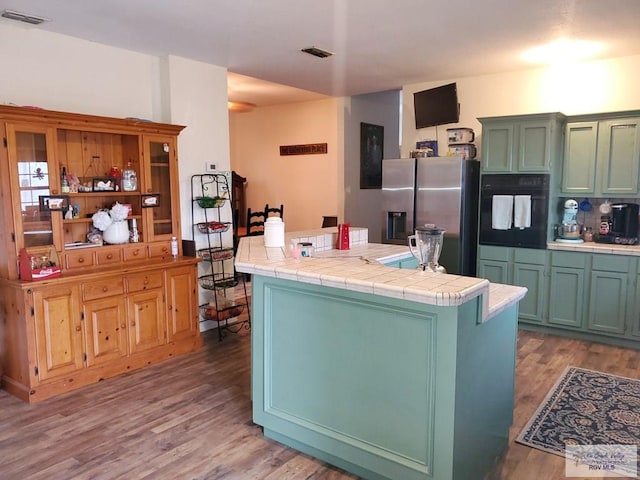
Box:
(482, 122), (514, 173)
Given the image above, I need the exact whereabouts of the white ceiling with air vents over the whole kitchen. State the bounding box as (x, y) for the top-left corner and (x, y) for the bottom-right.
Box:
(0, 0), (640, 105)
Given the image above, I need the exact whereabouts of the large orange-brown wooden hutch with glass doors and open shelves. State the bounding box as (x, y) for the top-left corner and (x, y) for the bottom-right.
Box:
(0, 106), (202, 402)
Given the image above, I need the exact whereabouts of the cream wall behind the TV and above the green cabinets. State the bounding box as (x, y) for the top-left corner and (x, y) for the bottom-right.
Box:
(402, 56), (640, 157)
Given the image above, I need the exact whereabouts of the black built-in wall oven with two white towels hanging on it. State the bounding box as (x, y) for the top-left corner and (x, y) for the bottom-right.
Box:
(479, 174), (549, 249)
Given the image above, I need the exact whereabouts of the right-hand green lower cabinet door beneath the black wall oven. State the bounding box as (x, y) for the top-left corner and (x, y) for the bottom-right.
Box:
(513, 263), (547, 323)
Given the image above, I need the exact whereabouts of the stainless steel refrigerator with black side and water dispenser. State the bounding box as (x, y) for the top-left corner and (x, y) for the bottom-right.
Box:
(382, 156), (480, 276)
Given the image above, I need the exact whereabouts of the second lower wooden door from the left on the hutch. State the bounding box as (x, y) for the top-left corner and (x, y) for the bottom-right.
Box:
(84, 296), (129, 366)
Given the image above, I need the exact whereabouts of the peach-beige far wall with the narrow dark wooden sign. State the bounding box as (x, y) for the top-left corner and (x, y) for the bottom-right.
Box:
(229, 99), (344, 231)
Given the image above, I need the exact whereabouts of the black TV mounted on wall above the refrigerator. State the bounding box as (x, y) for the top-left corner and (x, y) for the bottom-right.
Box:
(413, 83), (460, 129)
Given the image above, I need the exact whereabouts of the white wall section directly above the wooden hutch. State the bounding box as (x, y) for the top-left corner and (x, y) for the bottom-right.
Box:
(0, 23), (160, 120)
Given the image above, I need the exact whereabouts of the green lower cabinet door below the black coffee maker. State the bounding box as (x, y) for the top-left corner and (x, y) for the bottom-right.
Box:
(587, 271), (628, 335)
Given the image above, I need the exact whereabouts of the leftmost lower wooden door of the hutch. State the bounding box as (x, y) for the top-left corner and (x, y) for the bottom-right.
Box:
(32, 286), (84, 380)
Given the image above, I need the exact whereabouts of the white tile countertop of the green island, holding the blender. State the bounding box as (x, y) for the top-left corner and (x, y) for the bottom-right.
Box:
(235, 227), (527, 321)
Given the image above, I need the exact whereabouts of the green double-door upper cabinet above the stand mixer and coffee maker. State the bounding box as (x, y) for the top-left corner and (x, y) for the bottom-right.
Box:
(562, 112), (640, 197)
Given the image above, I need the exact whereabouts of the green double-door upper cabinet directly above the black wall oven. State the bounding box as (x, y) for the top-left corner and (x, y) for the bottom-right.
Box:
(478, 113), (565, 173)
